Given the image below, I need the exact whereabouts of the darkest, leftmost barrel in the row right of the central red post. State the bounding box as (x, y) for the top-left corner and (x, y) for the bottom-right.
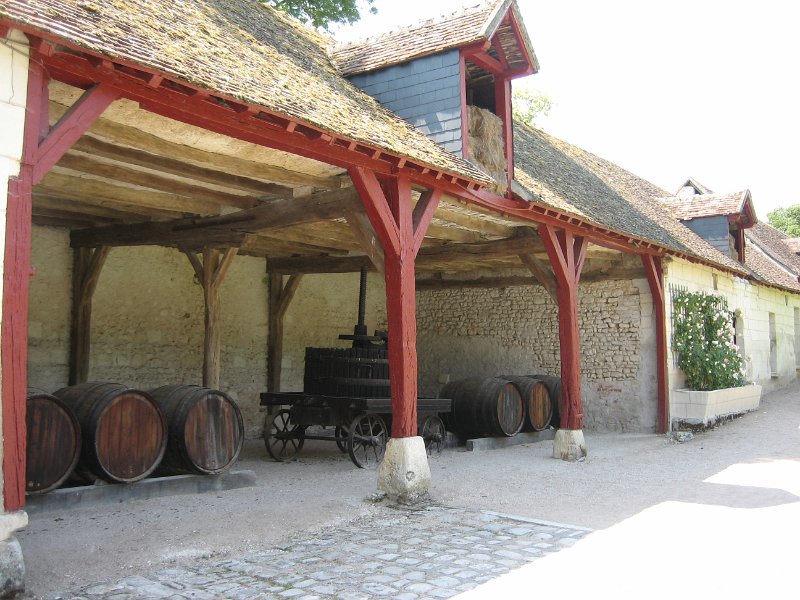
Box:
(439, 378), (525, 437)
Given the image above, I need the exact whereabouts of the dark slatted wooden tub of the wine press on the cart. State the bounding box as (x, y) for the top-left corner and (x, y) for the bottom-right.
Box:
(303, 348), (391, 398)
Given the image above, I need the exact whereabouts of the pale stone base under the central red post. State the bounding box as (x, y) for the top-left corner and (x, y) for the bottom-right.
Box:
(378, 436), (431, 504)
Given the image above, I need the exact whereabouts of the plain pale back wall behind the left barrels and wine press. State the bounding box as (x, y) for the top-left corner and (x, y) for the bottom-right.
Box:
(28, 227), (385, 437)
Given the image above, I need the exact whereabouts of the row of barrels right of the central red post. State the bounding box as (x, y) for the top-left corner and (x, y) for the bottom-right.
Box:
(439, 375), (561, 437)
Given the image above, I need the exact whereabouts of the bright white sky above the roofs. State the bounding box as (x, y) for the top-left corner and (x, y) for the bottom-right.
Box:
(335, 0), (800, 219)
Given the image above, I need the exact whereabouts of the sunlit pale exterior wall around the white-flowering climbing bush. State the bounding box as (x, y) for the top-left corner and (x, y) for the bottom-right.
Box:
(665, 259), (800, 393)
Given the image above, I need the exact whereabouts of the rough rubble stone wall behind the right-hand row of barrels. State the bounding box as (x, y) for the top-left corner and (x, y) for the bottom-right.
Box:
(417, 279), (656, 432)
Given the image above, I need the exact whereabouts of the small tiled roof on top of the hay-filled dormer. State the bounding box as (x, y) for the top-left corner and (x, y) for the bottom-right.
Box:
(333, 0), (538, 76)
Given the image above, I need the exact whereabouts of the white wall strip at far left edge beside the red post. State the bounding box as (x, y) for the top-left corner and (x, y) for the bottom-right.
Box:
(0, 31), (28, 506)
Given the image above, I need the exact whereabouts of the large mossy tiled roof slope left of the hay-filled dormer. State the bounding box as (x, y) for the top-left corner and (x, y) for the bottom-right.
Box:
(0, 0), (491, 183)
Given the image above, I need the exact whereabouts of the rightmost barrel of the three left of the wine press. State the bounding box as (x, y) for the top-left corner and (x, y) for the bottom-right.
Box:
(150, 385), (244, 475)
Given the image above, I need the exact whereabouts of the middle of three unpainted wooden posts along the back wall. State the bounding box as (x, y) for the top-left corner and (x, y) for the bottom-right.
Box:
(184, 248), (239, 389)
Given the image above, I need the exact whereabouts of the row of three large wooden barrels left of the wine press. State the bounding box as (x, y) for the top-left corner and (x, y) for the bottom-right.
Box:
(26, 382), (244, 494)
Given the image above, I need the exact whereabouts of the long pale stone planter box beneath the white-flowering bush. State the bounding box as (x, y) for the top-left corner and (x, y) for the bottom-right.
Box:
(670, 385), (761, 427)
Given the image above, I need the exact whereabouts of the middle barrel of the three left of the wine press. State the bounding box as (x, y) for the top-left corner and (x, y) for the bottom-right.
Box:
(55, 382), (167, 483)
